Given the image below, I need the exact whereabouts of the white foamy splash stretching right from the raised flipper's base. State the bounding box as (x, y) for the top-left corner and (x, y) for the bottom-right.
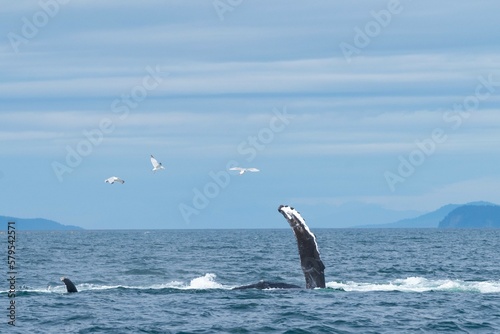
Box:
(326, 277), (500, 293)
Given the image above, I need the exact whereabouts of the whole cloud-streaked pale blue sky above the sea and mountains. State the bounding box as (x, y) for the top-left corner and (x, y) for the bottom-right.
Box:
(0, 0), (500, 229)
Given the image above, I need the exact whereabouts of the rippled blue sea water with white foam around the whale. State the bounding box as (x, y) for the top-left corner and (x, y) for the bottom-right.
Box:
(0, 229), (500, 333)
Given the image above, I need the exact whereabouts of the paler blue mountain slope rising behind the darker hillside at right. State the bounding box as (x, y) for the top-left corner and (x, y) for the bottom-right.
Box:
(357, 202), (496, 228)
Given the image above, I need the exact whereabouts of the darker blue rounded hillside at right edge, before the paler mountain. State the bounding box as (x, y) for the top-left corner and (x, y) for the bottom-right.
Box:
(439, 205), (500, 228)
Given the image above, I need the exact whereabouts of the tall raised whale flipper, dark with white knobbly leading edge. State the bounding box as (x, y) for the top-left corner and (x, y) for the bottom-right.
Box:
(278, 205), (325, 289)
